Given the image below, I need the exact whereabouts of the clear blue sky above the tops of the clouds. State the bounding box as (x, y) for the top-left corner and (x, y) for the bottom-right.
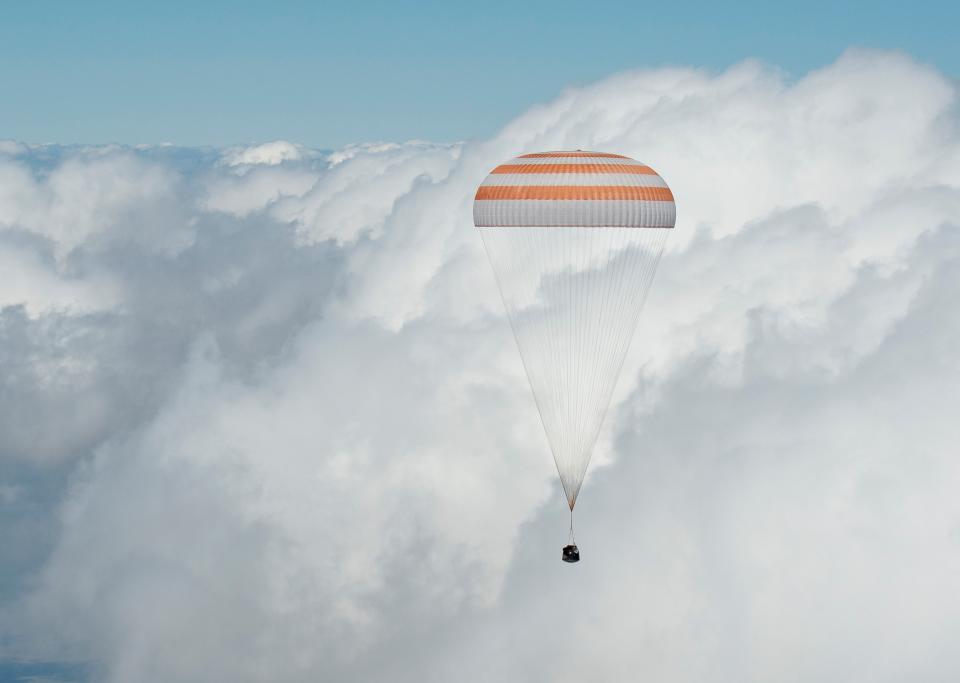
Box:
(0, 0), (960, 147)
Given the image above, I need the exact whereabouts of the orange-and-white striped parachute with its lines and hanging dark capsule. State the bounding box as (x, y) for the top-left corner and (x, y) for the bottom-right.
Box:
(473, 150), (676, 562)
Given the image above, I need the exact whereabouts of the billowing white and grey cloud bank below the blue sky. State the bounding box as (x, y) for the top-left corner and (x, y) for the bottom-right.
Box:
(0, 51), (960, 681)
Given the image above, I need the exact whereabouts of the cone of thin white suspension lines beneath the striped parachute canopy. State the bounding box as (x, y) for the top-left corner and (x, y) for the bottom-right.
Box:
(480, 226), (669, 504)
